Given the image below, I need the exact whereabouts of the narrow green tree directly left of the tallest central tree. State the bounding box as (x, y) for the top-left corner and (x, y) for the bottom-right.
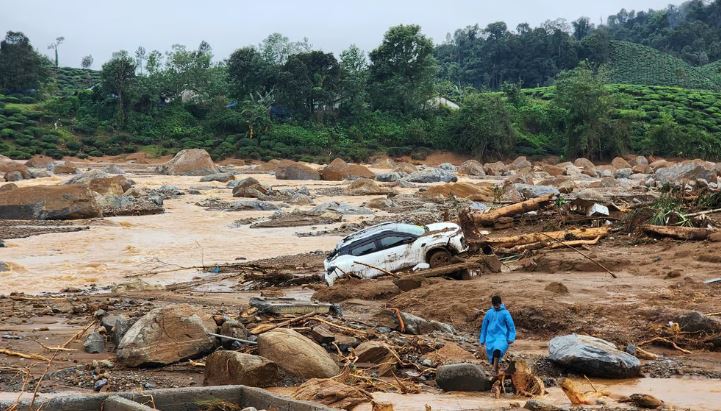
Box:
(340, 44), (368, 117)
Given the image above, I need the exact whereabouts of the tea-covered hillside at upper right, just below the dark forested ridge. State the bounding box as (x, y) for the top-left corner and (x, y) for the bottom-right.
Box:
(605, 41), (721, 91)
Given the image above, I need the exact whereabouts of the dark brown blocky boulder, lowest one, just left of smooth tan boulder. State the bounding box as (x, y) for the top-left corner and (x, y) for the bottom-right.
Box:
(203, 351), (282, 387)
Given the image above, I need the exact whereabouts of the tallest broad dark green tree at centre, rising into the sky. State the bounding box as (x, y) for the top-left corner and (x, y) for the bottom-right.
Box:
(369, 25), (436, 113)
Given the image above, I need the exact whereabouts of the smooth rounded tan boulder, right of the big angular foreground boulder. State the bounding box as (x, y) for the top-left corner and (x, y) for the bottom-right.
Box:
(258, 328), (340, 379)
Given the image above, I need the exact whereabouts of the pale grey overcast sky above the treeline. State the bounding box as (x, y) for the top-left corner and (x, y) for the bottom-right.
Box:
(0, 0), (679, 68)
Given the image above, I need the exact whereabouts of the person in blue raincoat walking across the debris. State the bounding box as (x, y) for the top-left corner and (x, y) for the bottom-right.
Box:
(479, 295), (516, 374)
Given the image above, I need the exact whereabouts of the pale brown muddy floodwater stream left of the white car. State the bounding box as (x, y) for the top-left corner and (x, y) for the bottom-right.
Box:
(0, 175), (368, 293)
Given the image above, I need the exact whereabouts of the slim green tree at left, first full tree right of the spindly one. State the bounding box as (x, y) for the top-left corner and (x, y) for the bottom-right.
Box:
(100, 50), (136, 127)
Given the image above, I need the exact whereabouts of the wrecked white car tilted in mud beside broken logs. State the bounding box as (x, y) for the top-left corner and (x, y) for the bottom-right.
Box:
(324, 223), (468, 285)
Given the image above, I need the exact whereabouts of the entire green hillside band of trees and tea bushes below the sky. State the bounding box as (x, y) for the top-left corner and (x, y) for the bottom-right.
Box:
(0, 0), (721, 161)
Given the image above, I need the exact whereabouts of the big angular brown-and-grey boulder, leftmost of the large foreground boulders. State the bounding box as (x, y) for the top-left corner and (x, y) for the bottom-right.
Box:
(117, 304), (216, 367)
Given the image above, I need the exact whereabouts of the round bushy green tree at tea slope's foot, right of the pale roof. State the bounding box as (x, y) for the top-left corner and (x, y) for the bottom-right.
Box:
(449, 92), (516, 159)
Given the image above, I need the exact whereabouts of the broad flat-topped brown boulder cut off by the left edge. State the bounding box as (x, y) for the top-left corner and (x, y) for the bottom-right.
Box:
(0, 185), (101, 220)
